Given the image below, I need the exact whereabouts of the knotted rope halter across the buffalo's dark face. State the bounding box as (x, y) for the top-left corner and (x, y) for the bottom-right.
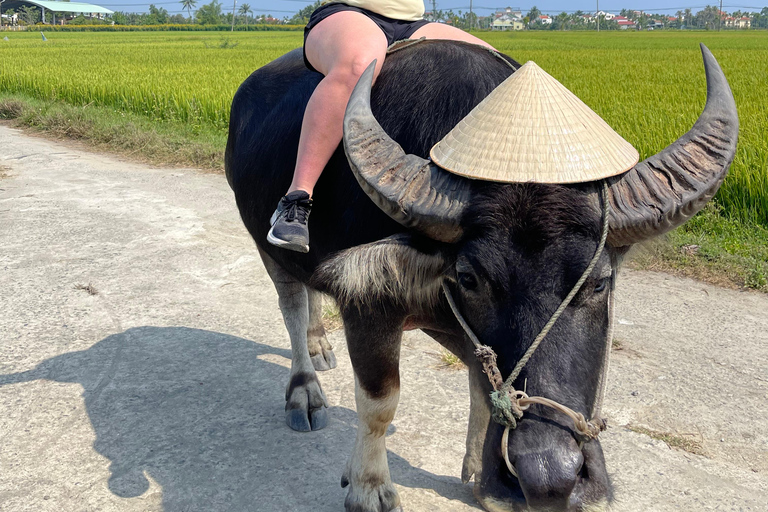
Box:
(442, 182), (610, 477)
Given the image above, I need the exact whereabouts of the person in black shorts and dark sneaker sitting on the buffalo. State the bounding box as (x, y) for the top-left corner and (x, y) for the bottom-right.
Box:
(267, 0), (492, 252)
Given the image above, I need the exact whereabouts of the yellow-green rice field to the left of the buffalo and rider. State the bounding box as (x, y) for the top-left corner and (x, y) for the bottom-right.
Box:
(0, 32), (302, 130)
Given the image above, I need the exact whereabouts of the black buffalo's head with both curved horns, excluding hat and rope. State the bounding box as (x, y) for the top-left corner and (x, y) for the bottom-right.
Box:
(344, 45), (738, 511)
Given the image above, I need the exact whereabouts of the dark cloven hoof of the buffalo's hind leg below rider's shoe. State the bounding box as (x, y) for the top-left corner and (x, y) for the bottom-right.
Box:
(285, 373), (328, 432)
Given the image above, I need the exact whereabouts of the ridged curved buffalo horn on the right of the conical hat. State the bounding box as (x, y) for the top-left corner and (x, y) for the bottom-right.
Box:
(608, 44), (739, 247)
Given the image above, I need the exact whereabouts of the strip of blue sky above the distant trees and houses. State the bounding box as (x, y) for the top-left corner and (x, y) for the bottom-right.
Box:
(91, 0), (768, 18)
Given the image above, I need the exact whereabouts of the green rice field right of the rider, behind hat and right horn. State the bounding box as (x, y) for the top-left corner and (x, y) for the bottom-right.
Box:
(478, 31), (768, 227)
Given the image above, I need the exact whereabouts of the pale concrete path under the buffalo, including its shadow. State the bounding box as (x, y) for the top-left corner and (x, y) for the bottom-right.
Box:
(0, 127), (768, 512)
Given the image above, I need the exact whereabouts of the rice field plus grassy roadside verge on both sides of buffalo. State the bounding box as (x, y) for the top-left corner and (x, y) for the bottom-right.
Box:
(0, 31), (768, 291)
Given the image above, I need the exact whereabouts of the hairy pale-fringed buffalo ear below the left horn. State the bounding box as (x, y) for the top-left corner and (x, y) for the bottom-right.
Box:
(310, 234), (449, 307)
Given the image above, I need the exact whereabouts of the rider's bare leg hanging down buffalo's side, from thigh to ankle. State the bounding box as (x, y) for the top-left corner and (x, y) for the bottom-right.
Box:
(288, 11), (387, 196)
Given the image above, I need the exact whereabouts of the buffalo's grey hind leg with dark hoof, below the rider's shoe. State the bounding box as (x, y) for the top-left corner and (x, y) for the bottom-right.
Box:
(259, 250), (328, 432)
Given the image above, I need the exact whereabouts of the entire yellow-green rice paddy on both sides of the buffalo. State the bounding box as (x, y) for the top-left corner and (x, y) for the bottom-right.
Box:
(0, 31), (768, 226)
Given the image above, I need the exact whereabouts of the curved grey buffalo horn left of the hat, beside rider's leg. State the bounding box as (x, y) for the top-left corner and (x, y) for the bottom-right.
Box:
(344, 61), (470, 242)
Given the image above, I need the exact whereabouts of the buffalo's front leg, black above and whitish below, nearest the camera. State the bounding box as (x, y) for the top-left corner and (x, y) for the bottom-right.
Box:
(341, 306), (404, 512)
